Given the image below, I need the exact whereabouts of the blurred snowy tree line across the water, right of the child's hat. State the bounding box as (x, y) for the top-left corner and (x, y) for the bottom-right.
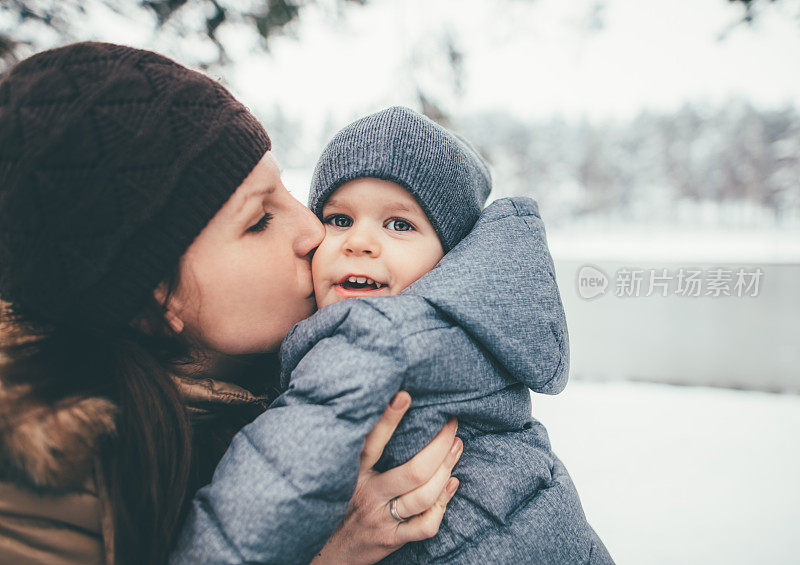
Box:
(458, 102), (800, 226)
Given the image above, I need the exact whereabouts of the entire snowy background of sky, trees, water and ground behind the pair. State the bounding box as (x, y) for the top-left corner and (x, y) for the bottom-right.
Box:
(0, 0), (800, 564)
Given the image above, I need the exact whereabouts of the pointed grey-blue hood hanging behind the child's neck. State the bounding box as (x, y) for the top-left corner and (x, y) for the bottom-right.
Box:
(403, 197), (569, 394)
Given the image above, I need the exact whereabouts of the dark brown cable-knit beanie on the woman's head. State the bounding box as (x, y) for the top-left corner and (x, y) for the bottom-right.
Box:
(0, 43), (270, 328)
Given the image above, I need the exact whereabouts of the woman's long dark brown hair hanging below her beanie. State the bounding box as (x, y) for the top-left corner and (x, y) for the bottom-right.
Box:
(0, 269), (192, 564)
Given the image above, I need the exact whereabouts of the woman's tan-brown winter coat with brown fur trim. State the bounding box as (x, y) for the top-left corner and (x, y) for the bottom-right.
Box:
(0, 377), (267, 565)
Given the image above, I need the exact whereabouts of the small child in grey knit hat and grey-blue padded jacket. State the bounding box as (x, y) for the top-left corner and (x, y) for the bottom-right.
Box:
(180, 108), (613, 564)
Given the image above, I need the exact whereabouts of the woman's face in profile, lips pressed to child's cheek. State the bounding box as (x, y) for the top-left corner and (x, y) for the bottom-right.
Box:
(162, 153), (325, 355)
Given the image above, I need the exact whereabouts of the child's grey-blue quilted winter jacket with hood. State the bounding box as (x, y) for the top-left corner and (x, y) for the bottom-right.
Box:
(173, 198), (613, 564)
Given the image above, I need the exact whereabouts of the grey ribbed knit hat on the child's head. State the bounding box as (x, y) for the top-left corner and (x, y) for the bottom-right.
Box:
(308, 106), (492, 253)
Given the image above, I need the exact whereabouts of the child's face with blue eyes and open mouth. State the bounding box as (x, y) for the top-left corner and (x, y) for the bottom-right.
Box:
(311, 178), (444, 308)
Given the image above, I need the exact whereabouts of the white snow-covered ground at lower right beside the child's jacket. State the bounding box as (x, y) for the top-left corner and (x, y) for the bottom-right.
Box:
(533, 381), (800, 565)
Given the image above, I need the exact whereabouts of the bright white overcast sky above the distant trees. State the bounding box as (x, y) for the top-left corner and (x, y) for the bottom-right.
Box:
(222, 0), (800, 123)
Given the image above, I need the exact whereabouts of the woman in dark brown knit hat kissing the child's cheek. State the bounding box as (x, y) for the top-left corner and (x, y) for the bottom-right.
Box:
(0, 43), (459, 563)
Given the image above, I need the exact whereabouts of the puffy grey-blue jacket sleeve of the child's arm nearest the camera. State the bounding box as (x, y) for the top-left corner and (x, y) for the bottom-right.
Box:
(170, 301), (405, 564)
